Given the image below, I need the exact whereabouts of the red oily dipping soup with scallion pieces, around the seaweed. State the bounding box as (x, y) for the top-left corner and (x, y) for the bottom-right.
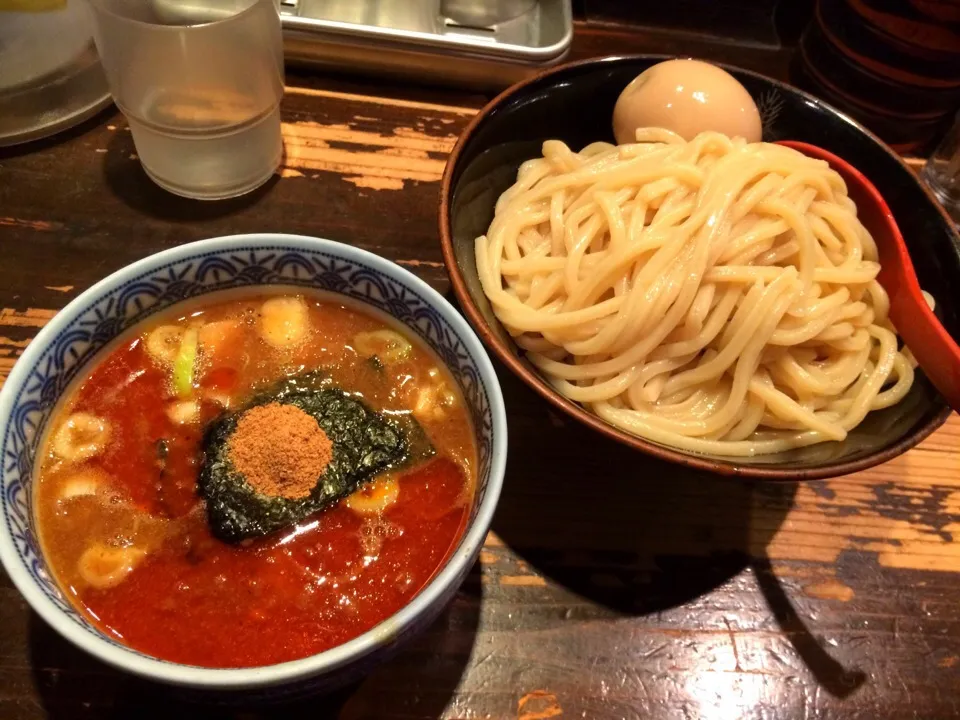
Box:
(35, 291), (476, 668)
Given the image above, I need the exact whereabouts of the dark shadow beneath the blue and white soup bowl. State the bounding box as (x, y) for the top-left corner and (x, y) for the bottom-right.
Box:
(30, 563), (482, 720)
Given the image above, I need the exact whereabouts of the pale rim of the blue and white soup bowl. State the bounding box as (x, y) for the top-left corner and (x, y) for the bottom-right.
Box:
(0, 233), (507, 690)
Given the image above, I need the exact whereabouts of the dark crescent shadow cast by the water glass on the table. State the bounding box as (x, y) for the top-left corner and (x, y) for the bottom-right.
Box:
(103, 125), (280, 222)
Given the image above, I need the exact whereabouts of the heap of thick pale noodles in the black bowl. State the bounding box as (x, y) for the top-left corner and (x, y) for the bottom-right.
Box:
(476, 129), (915, 456)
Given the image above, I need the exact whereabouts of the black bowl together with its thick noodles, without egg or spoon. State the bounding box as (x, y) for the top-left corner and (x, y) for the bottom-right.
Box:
(440, 56), (960, 480)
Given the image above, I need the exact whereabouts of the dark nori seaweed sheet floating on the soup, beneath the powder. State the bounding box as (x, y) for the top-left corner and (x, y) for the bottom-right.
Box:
(199, 371), (434, 543)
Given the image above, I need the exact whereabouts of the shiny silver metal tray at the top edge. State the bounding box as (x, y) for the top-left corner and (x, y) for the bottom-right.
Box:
(280, 0), (573, 90)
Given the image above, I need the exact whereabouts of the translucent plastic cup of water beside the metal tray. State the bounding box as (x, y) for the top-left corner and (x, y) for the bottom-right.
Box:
(90, 0), (283, 200)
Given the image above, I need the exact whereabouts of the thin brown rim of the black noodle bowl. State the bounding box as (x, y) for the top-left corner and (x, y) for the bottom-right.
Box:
(438, 53), (960, 482)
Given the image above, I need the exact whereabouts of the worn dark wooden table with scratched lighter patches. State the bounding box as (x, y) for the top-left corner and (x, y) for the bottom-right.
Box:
(0, 27), (960, 720)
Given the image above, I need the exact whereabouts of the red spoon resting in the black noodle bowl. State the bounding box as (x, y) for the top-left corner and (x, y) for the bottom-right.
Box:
(778, 140), (960, 413)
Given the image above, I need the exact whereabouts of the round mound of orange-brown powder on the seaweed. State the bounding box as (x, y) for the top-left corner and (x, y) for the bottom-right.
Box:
(228, 402), (333, 499)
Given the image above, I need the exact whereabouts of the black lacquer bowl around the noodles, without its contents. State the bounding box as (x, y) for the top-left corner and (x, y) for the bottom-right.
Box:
(440, 55), (960, 480)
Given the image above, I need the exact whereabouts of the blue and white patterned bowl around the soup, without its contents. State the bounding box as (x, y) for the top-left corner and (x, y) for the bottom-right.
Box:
(0, 234), (507, 696)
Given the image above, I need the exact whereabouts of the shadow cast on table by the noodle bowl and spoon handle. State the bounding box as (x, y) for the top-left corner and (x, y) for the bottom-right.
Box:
(493, 368), (865, 697)
